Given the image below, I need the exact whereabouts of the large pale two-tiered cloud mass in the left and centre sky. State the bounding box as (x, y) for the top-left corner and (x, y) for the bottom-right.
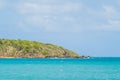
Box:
(17, 0), (82, 32)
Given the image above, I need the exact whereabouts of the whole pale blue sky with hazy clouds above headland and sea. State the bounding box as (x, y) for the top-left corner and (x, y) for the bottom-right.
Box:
(0, 0), (120, 57)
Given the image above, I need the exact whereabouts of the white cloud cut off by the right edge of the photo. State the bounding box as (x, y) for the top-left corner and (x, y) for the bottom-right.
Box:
(99, 6), (120, 31)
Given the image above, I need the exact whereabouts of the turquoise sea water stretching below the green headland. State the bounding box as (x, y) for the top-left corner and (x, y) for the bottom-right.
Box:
(0, 58), (120, 80)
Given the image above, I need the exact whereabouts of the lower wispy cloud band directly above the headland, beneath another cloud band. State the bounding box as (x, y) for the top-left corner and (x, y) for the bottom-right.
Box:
(19, 15), (81, 32)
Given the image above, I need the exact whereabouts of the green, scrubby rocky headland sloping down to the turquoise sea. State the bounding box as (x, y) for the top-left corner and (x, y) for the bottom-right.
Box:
(0, 39), (80, 58)
